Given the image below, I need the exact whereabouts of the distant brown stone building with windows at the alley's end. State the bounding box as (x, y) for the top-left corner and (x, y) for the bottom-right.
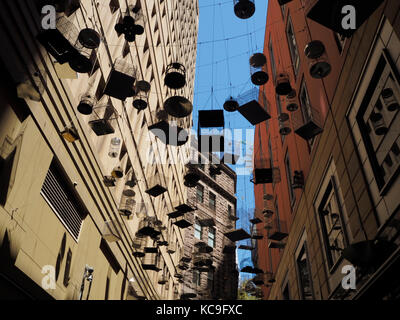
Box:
(178, 141), (238, 300)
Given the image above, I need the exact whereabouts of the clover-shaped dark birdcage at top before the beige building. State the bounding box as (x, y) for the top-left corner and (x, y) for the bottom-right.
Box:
(115, 6), (145, 42)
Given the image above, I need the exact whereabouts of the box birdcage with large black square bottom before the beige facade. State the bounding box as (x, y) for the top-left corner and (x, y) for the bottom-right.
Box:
(104, 58), (137, 101)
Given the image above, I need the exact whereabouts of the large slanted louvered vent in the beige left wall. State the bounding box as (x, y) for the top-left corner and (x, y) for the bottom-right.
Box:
(40, 162), (83, 240)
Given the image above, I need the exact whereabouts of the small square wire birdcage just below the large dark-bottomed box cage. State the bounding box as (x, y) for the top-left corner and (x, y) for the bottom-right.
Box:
(89, 100), (117, 136)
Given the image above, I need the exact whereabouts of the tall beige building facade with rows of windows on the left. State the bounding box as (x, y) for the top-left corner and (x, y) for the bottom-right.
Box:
(0, 0), (199, 300)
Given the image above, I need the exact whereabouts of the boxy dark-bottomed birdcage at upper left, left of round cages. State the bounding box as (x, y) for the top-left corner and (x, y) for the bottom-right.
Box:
(37, 16), (79, 64)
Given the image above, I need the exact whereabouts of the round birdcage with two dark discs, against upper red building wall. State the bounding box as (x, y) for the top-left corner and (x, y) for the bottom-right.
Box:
(304, 40), (332, 79)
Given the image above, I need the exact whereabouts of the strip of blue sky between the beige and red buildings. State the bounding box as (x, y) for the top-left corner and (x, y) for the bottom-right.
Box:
(193, 0), (268, 278)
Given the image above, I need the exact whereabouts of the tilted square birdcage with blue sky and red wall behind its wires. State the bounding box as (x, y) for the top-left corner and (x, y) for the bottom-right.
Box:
(238, 88), (271, 125)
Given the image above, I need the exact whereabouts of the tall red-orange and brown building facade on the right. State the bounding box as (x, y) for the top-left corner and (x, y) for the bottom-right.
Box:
(255, 1), (400, 300)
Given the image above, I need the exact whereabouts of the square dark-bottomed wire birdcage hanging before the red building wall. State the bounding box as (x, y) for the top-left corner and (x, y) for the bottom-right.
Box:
(292, 100), (323, 140)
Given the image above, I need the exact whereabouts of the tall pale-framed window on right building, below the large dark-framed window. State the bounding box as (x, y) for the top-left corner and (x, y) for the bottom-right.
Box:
(318, 176), (347, 268)
